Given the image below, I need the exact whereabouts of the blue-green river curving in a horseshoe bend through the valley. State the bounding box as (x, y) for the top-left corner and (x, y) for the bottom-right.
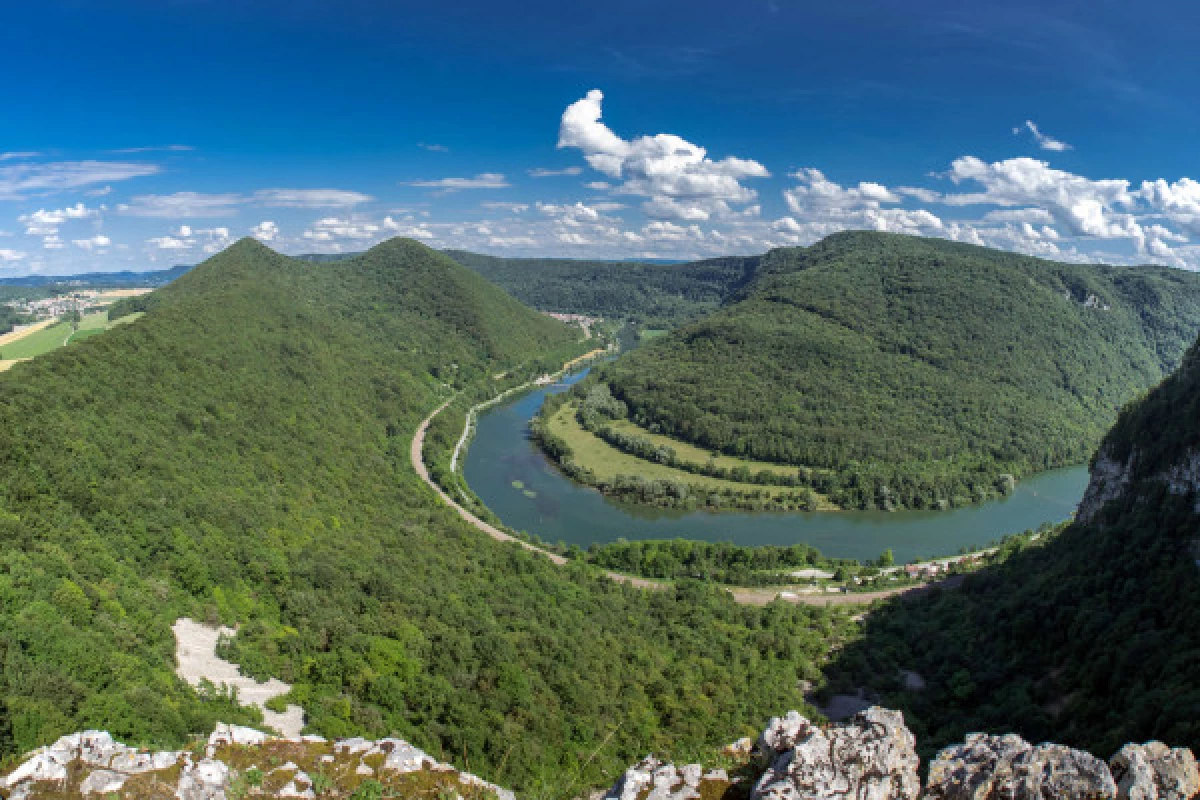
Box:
(463, 371), (1087, 564)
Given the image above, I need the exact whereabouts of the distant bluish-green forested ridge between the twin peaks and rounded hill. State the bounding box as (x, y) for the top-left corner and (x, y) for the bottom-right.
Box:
(446, 249), (758, 327)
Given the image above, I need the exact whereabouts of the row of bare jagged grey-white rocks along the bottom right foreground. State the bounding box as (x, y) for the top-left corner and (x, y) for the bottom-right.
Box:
(604, 708), (1200, 800)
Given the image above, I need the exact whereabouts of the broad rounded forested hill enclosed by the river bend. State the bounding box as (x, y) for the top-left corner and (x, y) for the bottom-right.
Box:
(604, 233), (1200, 507)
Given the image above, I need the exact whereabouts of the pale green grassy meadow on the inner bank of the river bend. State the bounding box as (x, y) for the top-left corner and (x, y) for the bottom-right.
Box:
(546, 403), (836, 511)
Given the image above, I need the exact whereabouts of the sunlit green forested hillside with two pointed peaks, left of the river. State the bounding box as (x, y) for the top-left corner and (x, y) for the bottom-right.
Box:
(0, 240), (849, 795)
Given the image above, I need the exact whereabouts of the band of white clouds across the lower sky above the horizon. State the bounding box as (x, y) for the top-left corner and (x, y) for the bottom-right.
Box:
(0, 89), (1200, 275)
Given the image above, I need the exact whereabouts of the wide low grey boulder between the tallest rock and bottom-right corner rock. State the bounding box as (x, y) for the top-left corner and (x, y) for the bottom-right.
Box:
(925, 733), (1117, 800)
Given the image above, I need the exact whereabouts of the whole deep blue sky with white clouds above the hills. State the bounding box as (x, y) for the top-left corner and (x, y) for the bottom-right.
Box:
(0, 0), (1200, 275)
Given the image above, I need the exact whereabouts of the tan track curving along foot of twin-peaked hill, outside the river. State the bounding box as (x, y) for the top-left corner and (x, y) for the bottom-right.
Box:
(409, 398), (928, 606)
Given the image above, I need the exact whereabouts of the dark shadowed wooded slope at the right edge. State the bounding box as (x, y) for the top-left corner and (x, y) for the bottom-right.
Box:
(830, 335), (1200, 752)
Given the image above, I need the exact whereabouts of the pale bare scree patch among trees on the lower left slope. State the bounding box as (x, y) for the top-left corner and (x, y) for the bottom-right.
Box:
(170, 618), (304, 738)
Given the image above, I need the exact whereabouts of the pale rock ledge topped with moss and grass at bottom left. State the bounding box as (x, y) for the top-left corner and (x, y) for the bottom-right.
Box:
(0, 724), (515, 800)
